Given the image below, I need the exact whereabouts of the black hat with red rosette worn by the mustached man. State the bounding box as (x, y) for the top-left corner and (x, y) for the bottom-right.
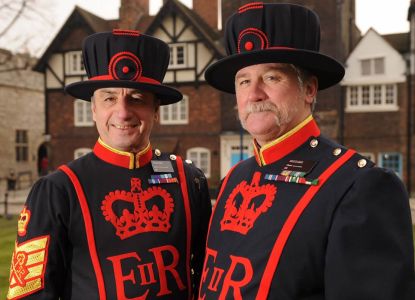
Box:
(205, 2), (344, 93)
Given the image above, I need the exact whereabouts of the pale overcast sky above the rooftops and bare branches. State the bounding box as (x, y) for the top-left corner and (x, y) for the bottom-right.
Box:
(0, 0), (410, 55)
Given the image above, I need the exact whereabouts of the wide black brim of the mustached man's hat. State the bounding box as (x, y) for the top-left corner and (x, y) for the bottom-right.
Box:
(205, 49), (345, 94)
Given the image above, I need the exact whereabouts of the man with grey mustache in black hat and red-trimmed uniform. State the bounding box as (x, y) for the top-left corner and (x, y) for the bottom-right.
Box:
(199, 2), (415, 300)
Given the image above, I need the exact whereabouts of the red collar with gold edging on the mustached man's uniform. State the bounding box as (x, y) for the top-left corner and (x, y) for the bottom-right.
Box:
(254, 115), (320, 166)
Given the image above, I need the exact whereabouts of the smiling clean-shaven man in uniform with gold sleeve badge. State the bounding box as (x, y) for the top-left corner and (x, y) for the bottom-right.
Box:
(8, 30), (211, 300)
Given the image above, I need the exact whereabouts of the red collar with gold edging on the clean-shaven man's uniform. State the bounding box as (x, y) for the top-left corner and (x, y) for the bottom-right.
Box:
(94, 138), (153, 169)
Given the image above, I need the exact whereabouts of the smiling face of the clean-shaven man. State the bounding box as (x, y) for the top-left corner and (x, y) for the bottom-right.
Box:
(91, 88), (159, 152)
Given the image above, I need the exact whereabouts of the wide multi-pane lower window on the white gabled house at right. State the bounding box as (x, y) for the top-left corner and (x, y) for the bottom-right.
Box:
(346, 84), (398, 111)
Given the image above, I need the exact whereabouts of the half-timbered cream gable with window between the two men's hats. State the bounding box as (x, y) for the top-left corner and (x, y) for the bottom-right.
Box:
(146, 0), (223, 85)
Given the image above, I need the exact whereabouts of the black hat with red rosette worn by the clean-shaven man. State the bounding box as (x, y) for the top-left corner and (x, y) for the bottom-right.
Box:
(65, 30), (183, 105)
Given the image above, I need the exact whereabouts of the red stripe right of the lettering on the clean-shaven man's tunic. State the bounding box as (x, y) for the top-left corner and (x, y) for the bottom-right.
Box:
(176, 156), (192, 300)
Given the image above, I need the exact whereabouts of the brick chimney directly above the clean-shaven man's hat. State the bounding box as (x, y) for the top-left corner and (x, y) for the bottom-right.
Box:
(118, 0), (150, 29)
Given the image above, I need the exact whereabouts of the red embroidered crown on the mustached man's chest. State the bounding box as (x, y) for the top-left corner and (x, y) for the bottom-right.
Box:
(220, 172), (277, 234)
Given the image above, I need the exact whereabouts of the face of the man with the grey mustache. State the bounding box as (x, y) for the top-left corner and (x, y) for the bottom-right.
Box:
(235, 63), (317, 145)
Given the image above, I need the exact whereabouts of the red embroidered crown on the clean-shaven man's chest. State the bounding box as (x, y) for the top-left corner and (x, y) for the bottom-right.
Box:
(101, 178), (174, 240)
